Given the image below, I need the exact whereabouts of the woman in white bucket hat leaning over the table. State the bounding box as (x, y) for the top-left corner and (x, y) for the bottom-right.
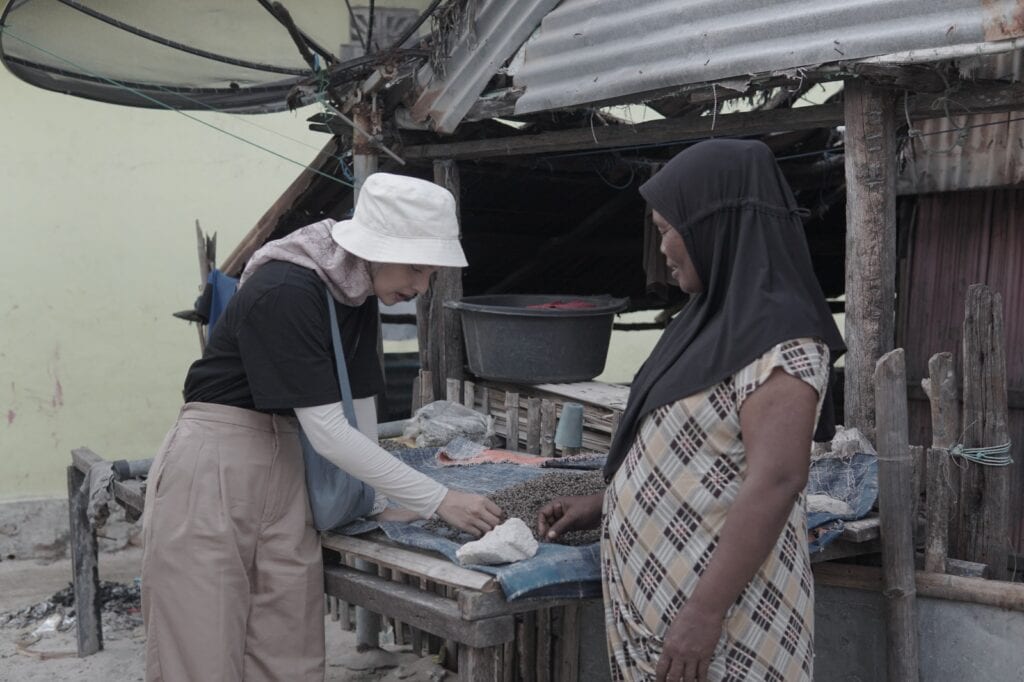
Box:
(142, 173), (502, 681)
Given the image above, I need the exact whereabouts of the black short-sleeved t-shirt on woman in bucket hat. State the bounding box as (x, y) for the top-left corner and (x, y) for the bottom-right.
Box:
(184, 261), (384, 414)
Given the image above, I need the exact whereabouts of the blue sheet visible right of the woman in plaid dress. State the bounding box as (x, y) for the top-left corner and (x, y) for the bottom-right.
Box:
(807, 453), (879, 554)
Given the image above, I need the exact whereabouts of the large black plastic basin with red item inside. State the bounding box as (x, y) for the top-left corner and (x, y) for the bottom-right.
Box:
(445, 294), (628, 384)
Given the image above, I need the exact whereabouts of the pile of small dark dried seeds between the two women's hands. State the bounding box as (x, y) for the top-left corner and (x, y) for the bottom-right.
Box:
(425, 471), (605, 545)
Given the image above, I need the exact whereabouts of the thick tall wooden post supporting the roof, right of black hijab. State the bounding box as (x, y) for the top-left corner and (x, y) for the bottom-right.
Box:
(843, 80), (906, 440)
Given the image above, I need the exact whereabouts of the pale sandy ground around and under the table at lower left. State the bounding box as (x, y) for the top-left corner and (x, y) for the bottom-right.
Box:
(0, 548), (455, 682)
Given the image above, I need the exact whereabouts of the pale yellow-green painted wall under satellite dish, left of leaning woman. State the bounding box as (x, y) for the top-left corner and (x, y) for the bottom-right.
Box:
(0, 68), (327, 500)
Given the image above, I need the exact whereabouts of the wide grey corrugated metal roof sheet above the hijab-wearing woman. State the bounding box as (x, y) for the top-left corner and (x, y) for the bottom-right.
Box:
(510, 0), (1024, 114)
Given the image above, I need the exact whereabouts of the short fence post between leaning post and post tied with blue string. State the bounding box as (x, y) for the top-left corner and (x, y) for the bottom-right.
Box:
(921, 353), (959, 573)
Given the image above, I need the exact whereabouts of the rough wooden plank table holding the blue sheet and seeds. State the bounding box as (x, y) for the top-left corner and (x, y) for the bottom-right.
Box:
(68, 440), (879, 682)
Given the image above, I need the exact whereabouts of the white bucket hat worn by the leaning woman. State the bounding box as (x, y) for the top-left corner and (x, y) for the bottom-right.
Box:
(331, 173), (469, 267)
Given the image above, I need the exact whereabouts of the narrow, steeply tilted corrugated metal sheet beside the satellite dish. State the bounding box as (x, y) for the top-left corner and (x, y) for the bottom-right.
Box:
(411, 0), (558, 133)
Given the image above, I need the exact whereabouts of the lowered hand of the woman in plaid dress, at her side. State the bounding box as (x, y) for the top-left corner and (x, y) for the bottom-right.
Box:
(654, 602), (723, 682)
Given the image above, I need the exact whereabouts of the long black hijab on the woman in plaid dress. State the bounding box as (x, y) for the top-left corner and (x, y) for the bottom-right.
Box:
(604, 139), (846, 480)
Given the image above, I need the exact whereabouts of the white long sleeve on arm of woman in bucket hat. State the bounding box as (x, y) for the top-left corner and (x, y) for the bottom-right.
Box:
(295, 398), (447, 518)
